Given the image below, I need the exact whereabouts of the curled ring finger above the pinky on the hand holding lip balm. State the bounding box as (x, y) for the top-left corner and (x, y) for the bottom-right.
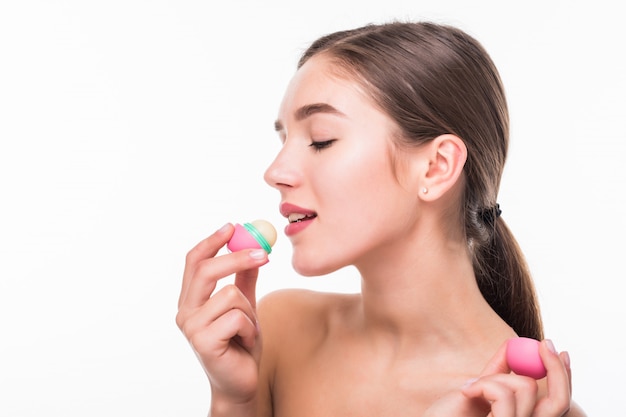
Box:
(181, 285), (257, 338)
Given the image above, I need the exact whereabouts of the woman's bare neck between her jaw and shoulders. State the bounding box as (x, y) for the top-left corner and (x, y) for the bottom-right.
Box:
(357, 229), (510, 349)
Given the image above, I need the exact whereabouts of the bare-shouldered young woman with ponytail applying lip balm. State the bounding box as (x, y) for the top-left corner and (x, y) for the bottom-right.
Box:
(177, 22), (583, 417)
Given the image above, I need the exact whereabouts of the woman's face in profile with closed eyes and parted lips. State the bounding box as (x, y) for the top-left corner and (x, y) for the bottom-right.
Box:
(265, 56), (419, 275)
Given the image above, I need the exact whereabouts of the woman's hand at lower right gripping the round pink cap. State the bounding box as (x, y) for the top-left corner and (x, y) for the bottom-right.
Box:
(424, 340), (582, 417)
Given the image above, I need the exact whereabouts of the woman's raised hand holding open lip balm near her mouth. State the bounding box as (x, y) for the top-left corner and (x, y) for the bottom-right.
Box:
(176, 224), (268, 408)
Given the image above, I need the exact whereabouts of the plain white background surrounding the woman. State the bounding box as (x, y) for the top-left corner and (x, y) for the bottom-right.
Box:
(0, 0), (626, 417)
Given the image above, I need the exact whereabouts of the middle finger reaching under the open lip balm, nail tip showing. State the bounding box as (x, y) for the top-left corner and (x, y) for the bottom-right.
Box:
(183, 250), (267, 309)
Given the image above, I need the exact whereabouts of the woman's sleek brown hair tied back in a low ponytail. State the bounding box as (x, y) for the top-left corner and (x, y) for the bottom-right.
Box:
(298, 22), (543, 339)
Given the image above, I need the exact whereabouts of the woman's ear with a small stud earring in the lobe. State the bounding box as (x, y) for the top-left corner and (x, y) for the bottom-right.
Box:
(419, 134), (467, 201)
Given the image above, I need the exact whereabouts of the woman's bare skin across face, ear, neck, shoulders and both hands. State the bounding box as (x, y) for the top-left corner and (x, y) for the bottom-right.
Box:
(177, 55), (584, 417)
